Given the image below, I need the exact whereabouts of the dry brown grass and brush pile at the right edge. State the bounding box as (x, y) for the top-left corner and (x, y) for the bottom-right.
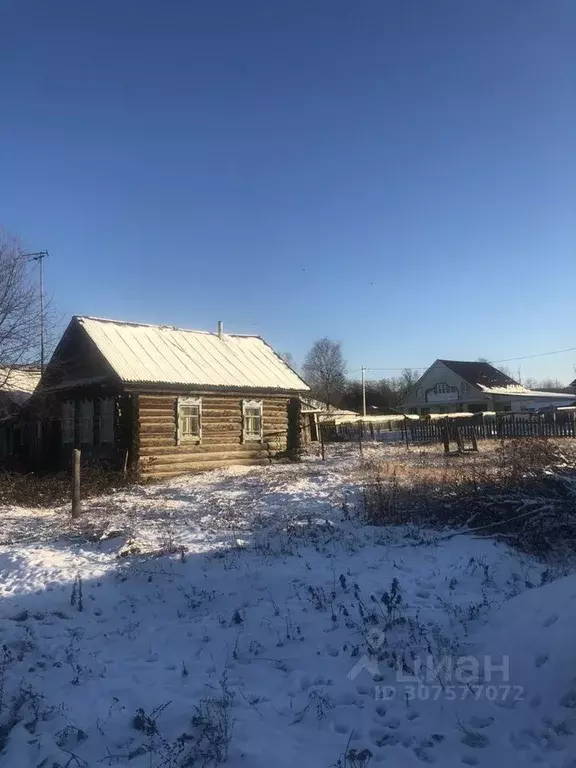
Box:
(361, 438), (576, 551)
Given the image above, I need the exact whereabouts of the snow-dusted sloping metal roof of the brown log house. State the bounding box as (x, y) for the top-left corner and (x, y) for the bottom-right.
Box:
(75, 317), (309, 392)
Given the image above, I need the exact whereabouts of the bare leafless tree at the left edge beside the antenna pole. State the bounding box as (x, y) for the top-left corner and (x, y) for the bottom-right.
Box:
(0, 226), (41, 386)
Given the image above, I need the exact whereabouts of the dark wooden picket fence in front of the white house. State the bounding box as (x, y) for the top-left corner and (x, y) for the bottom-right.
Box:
(322, 412), (576, 445)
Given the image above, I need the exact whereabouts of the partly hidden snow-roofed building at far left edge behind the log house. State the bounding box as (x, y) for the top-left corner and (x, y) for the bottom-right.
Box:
(0, 365), (40, 459)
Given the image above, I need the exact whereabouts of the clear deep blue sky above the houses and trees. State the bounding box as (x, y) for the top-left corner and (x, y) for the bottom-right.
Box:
(0, 0), (576, 381)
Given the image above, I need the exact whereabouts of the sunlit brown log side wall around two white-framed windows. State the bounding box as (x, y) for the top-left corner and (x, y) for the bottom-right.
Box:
(134, 393), (288, 479)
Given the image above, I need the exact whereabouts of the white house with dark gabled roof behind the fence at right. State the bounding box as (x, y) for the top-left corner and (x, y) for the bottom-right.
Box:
(398, 360), (575, 416)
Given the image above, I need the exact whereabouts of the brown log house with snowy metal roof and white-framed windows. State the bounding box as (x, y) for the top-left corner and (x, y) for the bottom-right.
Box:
(24, 317), (308, 478)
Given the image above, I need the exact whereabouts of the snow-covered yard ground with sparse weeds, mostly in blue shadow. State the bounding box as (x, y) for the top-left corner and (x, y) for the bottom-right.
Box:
(0, 449), (576, 768)
